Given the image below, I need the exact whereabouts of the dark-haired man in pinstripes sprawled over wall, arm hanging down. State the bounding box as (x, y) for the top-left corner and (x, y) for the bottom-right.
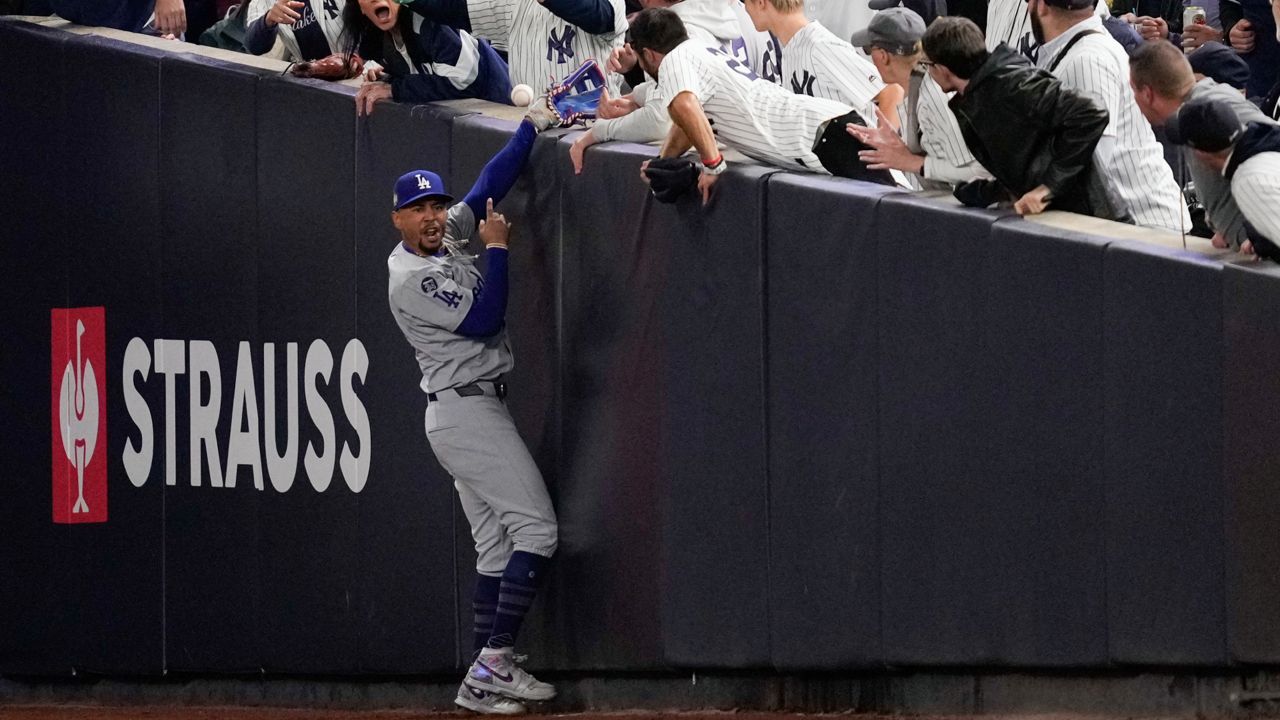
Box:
(631, 8), (893, 204)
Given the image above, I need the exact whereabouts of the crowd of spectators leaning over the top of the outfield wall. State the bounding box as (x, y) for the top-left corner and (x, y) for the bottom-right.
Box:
(0, 0), (1280, 256)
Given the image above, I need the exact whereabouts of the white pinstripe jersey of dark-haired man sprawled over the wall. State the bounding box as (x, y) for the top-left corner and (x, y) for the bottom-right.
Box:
(658, 40), (850, 174)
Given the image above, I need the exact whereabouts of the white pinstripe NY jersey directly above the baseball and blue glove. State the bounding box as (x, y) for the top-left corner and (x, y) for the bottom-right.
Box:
(507, 0), (627, 96)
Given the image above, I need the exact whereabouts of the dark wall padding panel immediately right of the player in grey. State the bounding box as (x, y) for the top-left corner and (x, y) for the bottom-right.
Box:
(556, 143), (680, 670)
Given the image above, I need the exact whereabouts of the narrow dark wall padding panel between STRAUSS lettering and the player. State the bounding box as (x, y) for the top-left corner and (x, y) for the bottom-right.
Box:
(355, 102), (470, 673)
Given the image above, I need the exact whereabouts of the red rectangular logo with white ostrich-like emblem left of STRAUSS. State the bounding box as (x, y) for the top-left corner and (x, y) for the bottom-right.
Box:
(50, 307), (106, 523)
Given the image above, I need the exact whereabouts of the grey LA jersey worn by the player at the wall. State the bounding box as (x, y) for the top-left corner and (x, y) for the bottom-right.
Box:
(387, 202), (515, 392)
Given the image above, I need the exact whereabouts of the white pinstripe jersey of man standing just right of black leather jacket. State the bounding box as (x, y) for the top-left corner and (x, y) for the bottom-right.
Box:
(1037, 17), (1190, 232)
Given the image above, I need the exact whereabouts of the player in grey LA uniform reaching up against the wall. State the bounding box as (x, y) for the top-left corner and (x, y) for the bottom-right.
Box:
(387, 104), (557, 715)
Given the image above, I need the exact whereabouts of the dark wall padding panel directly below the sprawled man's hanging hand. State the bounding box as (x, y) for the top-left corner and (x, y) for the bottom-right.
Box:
(655, 164), (774, 667)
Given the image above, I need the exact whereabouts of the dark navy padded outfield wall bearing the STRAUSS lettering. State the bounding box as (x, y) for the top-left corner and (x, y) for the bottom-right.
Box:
(0, 20), (1280, 676)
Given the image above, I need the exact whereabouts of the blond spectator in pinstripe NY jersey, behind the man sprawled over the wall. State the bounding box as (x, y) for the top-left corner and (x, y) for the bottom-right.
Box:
(746, 0), (902, 127)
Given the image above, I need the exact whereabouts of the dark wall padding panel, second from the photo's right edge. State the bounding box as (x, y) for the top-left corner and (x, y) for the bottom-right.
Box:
(1103, 242), (1226, 665)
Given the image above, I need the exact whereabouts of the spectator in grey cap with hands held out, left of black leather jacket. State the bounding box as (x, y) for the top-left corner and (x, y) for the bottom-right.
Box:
(849, 0), (991, 190)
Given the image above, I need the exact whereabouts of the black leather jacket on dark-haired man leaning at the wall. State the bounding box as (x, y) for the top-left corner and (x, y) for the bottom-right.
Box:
(950, 44), (1125, 220)
